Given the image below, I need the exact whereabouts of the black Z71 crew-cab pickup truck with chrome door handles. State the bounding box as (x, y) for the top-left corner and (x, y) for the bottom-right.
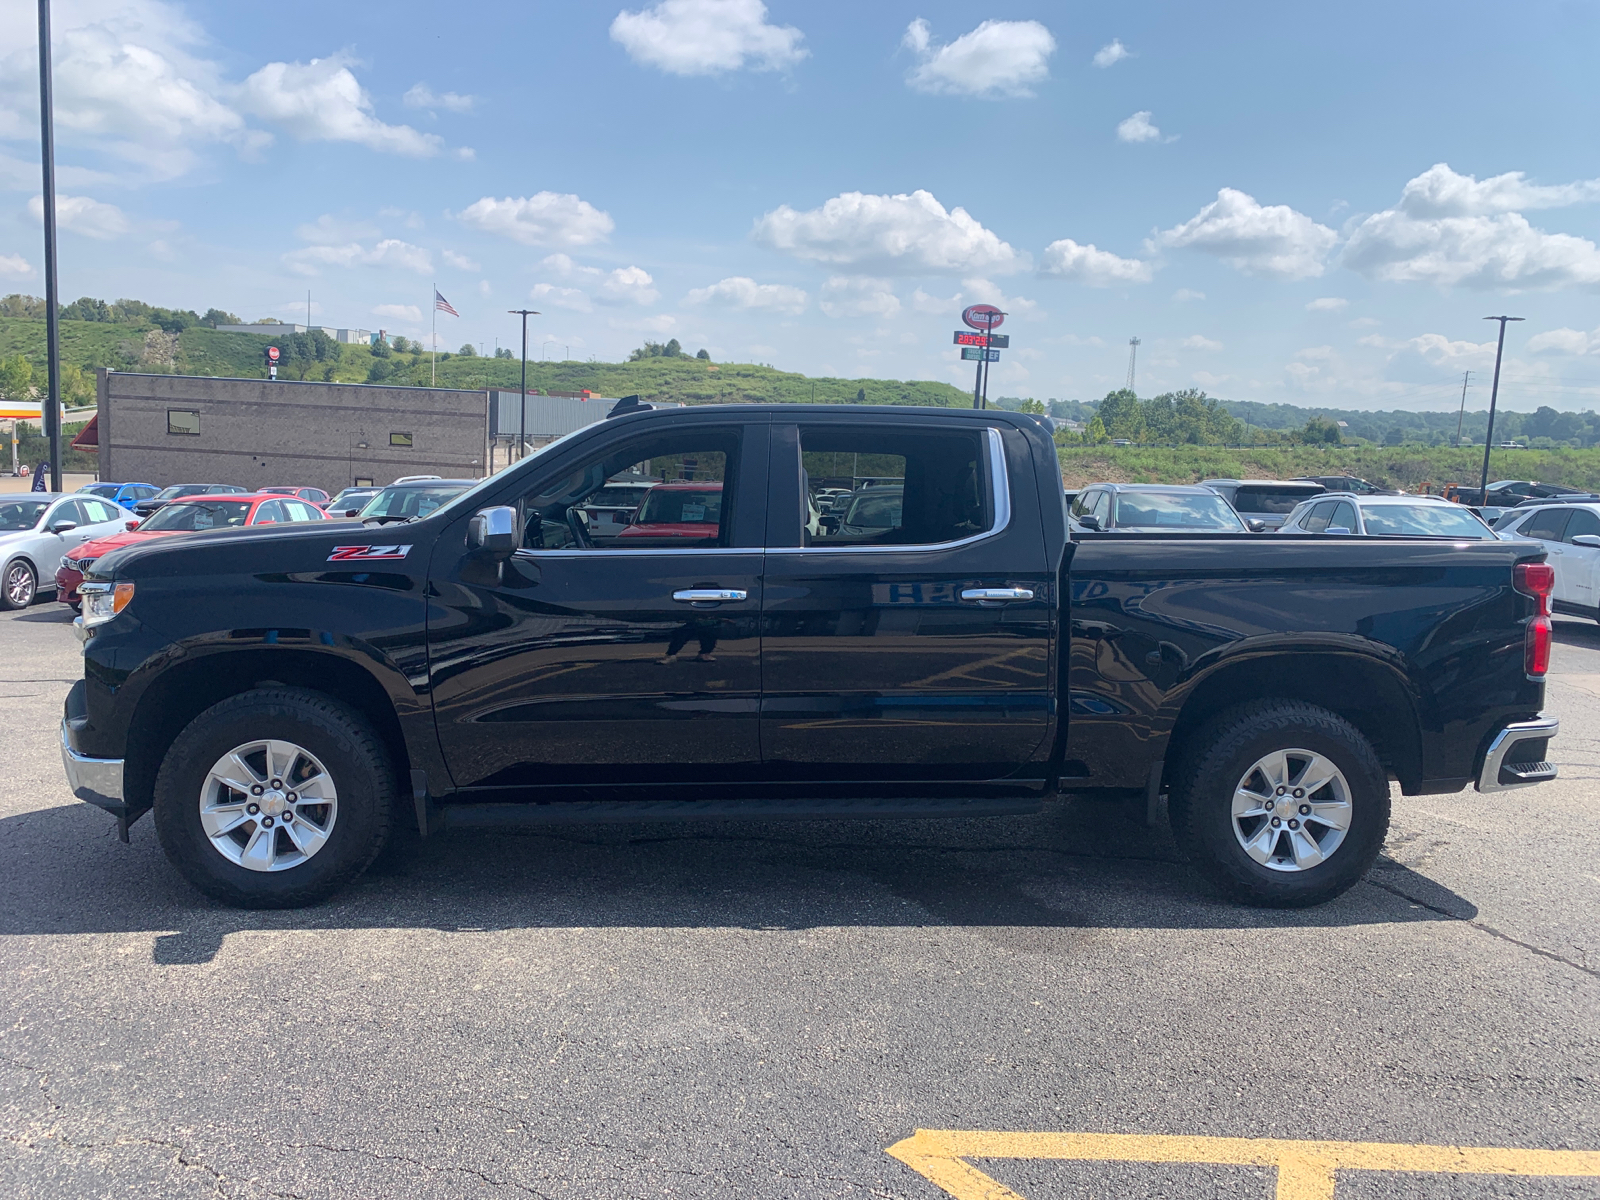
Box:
(61, 402), (1557, 907)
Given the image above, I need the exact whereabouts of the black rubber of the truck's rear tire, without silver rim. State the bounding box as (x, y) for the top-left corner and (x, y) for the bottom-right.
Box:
(1168, 699), (1389, 909)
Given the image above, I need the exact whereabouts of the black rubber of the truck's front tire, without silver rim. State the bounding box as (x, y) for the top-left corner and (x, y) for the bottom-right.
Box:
(155, 688), (395, 909)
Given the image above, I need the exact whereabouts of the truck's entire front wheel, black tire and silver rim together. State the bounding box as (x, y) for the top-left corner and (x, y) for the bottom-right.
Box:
(155, 688), (395, 909)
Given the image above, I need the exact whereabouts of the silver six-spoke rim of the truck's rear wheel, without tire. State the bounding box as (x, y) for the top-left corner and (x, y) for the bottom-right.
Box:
(1234, 750), (1354, 870)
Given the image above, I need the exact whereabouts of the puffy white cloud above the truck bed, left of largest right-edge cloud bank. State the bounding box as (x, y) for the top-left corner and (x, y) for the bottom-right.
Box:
(1152, 187), (1339, 278)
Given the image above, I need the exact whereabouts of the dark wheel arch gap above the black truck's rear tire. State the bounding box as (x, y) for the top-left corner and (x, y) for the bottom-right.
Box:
(1166, 648), (1422, 792)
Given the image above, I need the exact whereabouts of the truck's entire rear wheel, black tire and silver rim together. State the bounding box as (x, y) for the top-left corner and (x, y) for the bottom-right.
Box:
(1170, 701), (1389, 909)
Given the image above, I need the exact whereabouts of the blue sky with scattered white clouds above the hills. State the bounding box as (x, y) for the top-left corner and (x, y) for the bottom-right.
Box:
(0, 0), (1600, 410)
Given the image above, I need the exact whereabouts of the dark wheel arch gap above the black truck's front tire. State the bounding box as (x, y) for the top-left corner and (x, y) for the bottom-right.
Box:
(123, 646), (411, 816)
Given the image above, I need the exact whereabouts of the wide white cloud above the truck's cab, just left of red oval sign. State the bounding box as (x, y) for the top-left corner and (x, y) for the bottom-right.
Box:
(755, 190), (1024, 274)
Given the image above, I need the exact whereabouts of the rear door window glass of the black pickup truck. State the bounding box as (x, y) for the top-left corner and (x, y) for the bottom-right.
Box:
(800, 426), (994, 546)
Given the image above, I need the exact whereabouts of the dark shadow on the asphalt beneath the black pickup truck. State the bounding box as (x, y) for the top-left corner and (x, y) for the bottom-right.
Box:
(0, 802), (1477, 965)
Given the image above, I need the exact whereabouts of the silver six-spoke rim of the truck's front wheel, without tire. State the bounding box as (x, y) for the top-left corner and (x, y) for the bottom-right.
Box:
(200, 739), (339, 870)
